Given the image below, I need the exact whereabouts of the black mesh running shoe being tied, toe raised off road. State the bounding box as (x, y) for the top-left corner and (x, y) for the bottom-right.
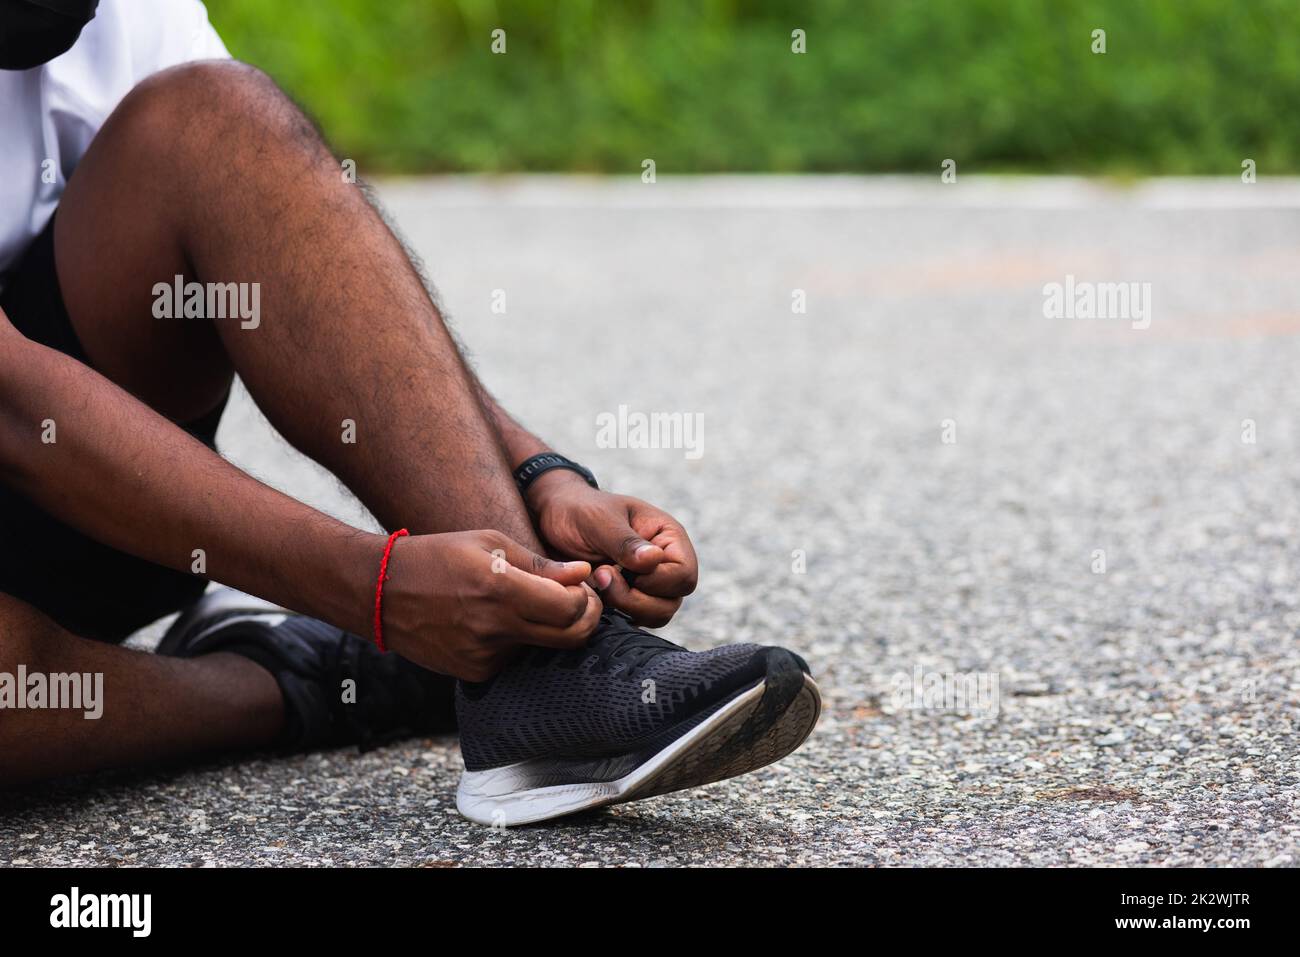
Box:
(456, 612), (822, 826)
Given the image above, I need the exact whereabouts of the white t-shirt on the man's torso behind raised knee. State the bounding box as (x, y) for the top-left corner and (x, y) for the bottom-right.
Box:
(0, 0), (230, 282)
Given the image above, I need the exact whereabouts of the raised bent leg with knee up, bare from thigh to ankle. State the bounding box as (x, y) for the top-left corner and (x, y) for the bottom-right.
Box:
(56, 62), (541, 551)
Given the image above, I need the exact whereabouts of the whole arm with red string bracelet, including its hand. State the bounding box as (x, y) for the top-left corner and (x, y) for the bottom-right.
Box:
(0, 312), (599, 680)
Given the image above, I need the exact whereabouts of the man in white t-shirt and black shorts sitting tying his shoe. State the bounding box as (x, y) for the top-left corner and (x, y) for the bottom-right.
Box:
(0, 0), (820, 824)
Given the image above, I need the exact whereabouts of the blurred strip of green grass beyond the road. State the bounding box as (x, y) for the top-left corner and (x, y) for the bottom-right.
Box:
(200, 0), (1300, 176)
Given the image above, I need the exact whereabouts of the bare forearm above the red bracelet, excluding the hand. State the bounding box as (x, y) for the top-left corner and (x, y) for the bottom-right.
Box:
(0, 329), (382, 631)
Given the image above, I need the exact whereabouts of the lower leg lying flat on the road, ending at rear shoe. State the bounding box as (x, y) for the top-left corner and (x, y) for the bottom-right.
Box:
(0, 594), (283, 784)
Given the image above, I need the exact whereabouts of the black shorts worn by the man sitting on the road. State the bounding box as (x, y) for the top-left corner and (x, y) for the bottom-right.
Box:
(0, 218), (225, 642)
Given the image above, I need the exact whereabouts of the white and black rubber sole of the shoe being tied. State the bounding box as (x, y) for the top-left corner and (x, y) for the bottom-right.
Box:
(456, 675), (822, 827)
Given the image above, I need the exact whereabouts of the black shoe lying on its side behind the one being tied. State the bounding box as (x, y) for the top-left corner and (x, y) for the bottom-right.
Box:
(157, 589), (456, 752)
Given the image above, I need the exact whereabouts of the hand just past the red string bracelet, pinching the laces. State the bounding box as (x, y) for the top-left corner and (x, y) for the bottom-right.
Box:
(376, 531), (602, 681)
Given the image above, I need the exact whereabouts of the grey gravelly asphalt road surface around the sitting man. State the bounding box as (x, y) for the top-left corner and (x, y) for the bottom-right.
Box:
(0, 177), (1300, 866)
